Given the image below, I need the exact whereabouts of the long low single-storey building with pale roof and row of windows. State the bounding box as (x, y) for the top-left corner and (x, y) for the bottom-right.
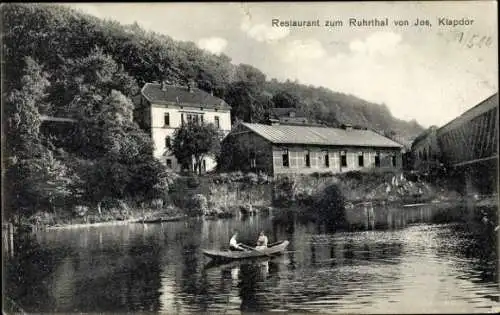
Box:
(224, 123), (403, 176)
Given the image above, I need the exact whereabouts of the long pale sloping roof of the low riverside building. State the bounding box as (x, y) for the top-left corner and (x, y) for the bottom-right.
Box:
(242, 123), (403, 148)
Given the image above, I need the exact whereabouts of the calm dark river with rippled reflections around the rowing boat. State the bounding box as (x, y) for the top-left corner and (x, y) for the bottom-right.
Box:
(4, 207), (499, 314)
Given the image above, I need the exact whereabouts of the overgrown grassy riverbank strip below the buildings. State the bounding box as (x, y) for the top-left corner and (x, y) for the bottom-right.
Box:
(7, 171), (497, 231)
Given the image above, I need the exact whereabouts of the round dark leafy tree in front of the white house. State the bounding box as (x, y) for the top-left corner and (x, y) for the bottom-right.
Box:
(169, 122), (222, 174)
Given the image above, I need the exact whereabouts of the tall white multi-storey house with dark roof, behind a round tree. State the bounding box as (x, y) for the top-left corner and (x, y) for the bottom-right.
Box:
(137, 82), (231, 171)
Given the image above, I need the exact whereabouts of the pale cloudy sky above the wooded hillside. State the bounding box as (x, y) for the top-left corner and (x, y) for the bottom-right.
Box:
(65, 1), (498, 127)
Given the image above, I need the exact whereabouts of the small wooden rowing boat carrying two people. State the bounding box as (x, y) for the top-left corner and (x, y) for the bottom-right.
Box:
(203, 241), (289, 261)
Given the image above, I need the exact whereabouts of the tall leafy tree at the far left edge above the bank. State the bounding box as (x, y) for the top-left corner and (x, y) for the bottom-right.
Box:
(4, 57), (77, 218)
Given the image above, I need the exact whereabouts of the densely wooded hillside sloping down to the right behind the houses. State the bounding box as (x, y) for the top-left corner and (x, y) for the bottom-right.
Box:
(2, 3), (423, 143)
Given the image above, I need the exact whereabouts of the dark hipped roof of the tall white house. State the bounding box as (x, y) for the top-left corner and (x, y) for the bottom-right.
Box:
(141, 83), (231, 109)
